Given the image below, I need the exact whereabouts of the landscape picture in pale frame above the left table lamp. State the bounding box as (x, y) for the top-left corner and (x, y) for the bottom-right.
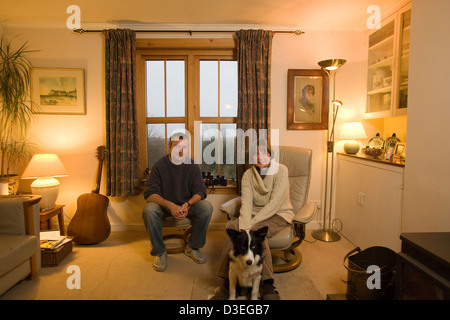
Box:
(30, 68), (86, 115)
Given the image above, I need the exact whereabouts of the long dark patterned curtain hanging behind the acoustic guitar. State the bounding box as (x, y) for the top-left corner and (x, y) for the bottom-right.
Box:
(103, 30), (139, 196)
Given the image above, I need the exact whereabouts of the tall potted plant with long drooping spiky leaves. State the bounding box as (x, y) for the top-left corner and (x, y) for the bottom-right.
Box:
(0, 36), (36, 194)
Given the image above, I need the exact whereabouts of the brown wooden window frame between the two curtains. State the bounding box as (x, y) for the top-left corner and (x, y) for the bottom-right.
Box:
(136, 38), (237, 194)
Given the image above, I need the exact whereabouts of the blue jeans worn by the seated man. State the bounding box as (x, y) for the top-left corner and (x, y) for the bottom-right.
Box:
(142, 200), (213, 256)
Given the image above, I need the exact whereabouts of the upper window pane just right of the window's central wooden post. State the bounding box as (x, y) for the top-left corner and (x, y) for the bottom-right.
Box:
(200, 61), (219, 117)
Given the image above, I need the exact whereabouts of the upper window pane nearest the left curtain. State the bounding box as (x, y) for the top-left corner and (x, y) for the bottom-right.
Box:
(146, 61), (165, 117)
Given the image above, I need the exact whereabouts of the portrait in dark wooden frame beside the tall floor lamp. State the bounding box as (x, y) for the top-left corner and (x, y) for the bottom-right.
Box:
(287, 69), (328, 130)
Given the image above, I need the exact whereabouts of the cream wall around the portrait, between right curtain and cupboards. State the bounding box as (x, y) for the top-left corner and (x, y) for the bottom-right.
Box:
(271, 30), (367, 228)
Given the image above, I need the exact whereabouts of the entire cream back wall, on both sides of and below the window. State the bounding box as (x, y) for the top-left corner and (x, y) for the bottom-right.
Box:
(4, 27), (366, 229)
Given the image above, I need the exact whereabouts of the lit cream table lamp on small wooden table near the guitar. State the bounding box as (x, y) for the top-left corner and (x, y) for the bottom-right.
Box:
(22, 153), (68, 211)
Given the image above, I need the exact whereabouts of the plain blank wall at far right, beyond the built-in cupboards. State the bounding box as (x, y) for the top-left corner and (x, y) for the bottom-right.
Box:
(402, 0), (450, 232)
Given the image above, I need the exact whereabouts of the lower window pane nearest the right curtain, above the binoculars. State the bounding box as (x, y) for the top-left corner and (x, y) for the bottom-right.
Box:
(220, 123), (236, 179)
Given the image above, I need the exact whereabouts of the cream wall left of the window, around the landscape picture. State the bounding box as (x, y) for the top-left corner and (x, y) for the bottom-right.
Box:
(4, 28), (105, 217)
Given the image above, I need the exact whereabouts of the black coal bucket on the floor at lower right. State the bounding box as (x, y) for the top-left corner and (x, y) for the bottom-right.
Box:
(344, 247), (397, 300)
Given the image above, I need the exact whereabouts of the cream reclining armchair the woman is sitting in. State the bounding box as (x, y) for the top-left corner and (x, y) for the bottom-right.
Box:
(219, 146), (318, 272)
